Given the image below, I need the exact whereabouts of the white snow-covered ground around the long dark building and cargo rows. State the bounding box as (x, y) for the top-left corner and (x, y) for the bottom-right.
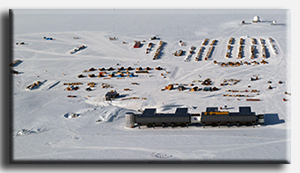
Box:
(13, 10), (291, 162)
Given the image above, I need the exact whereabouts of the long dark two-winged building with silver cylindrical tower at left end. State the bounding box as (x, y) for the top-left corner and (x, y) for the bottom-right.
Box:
(125, 106), (264, 128)
